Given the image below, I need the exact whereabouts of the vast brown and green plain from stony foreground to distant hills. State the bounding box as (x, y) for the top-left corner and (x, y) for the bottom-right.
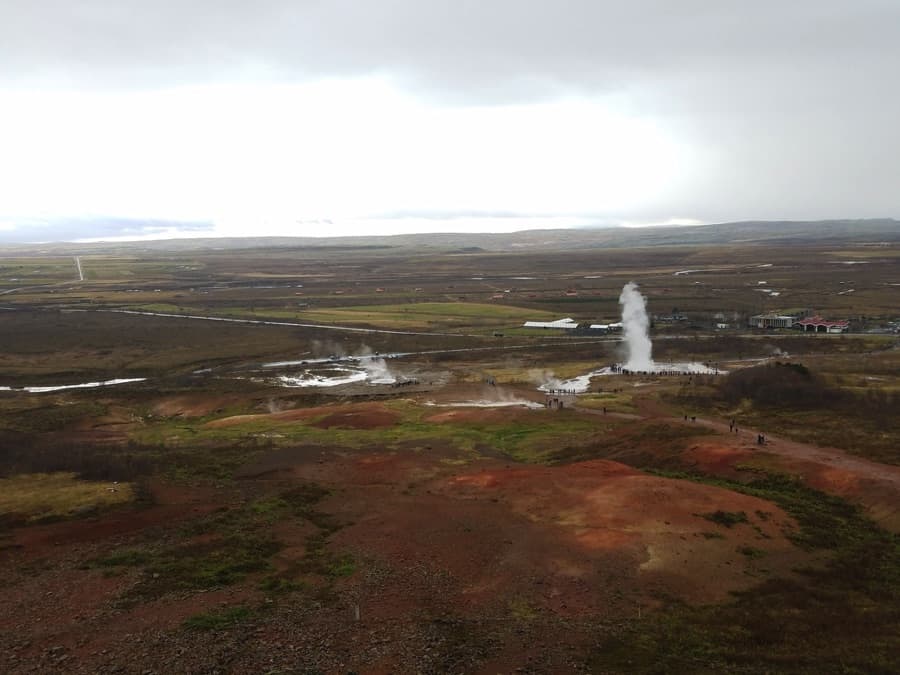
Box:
(0, 231), (900, 673)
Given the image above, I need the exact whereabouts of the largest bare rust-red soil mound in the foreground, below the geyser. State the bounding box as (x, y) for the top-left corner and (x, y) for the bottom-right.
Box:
(322, 455), (802, 615)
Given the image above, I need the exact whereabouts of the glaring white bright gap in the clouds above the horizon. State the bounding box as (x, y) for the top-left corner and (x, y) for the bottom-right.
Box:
(0, 78), (698, 236)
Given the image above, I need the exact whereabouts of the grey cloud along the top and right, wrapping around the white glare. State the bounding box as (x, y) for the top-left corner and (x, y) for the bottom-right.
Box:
(0, 0), (900, 226)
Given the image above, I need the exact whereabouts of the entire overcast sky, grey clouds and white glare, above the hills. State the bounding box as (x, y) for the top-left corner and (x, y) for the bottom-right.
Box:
(0, 0), (900, 241)
